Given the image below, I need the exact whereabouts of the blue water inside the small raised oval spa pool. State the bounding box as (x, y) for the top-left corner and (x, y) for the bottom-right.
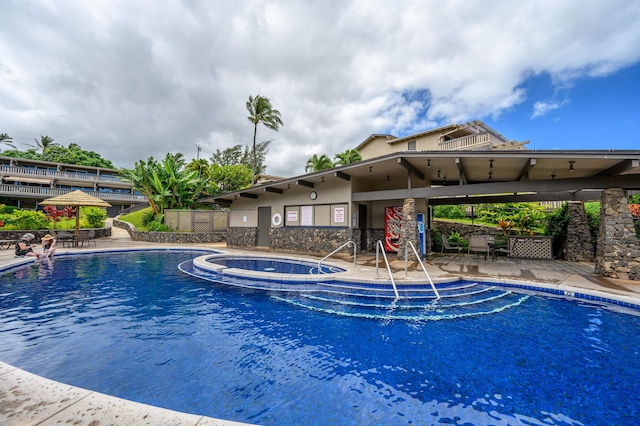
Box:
(209, 256), (344, 274)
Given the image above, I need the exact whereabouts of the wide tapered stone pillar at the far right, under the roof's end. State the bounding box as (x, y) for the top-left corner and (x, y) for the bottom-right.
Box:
(595, 188), (640, 280)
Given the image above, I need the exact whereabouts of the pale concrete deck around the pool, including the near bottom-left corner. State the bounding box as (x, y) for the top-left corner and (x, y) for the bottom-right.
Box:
(0, 228), (640, 426)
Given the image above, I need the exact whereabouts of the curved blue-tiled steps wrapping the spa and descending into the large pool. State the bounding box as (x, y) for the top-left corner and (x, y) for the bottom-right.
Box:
(180, 259), (529, 321)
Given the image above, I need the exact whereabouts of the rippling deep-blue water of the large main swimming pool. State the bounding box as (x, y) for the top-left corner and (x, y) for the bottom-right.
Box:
(0, 252), (640, 425)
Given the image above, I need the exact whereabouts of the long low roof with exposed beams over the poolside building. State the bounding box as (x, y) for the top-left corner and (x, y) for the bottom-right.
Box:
(202, 150), (640, 208)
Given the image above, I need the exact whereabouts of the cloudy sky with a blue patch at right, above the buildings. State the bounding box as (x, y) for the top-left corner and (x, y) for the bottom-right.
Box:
(0, 0), (640, 176)
